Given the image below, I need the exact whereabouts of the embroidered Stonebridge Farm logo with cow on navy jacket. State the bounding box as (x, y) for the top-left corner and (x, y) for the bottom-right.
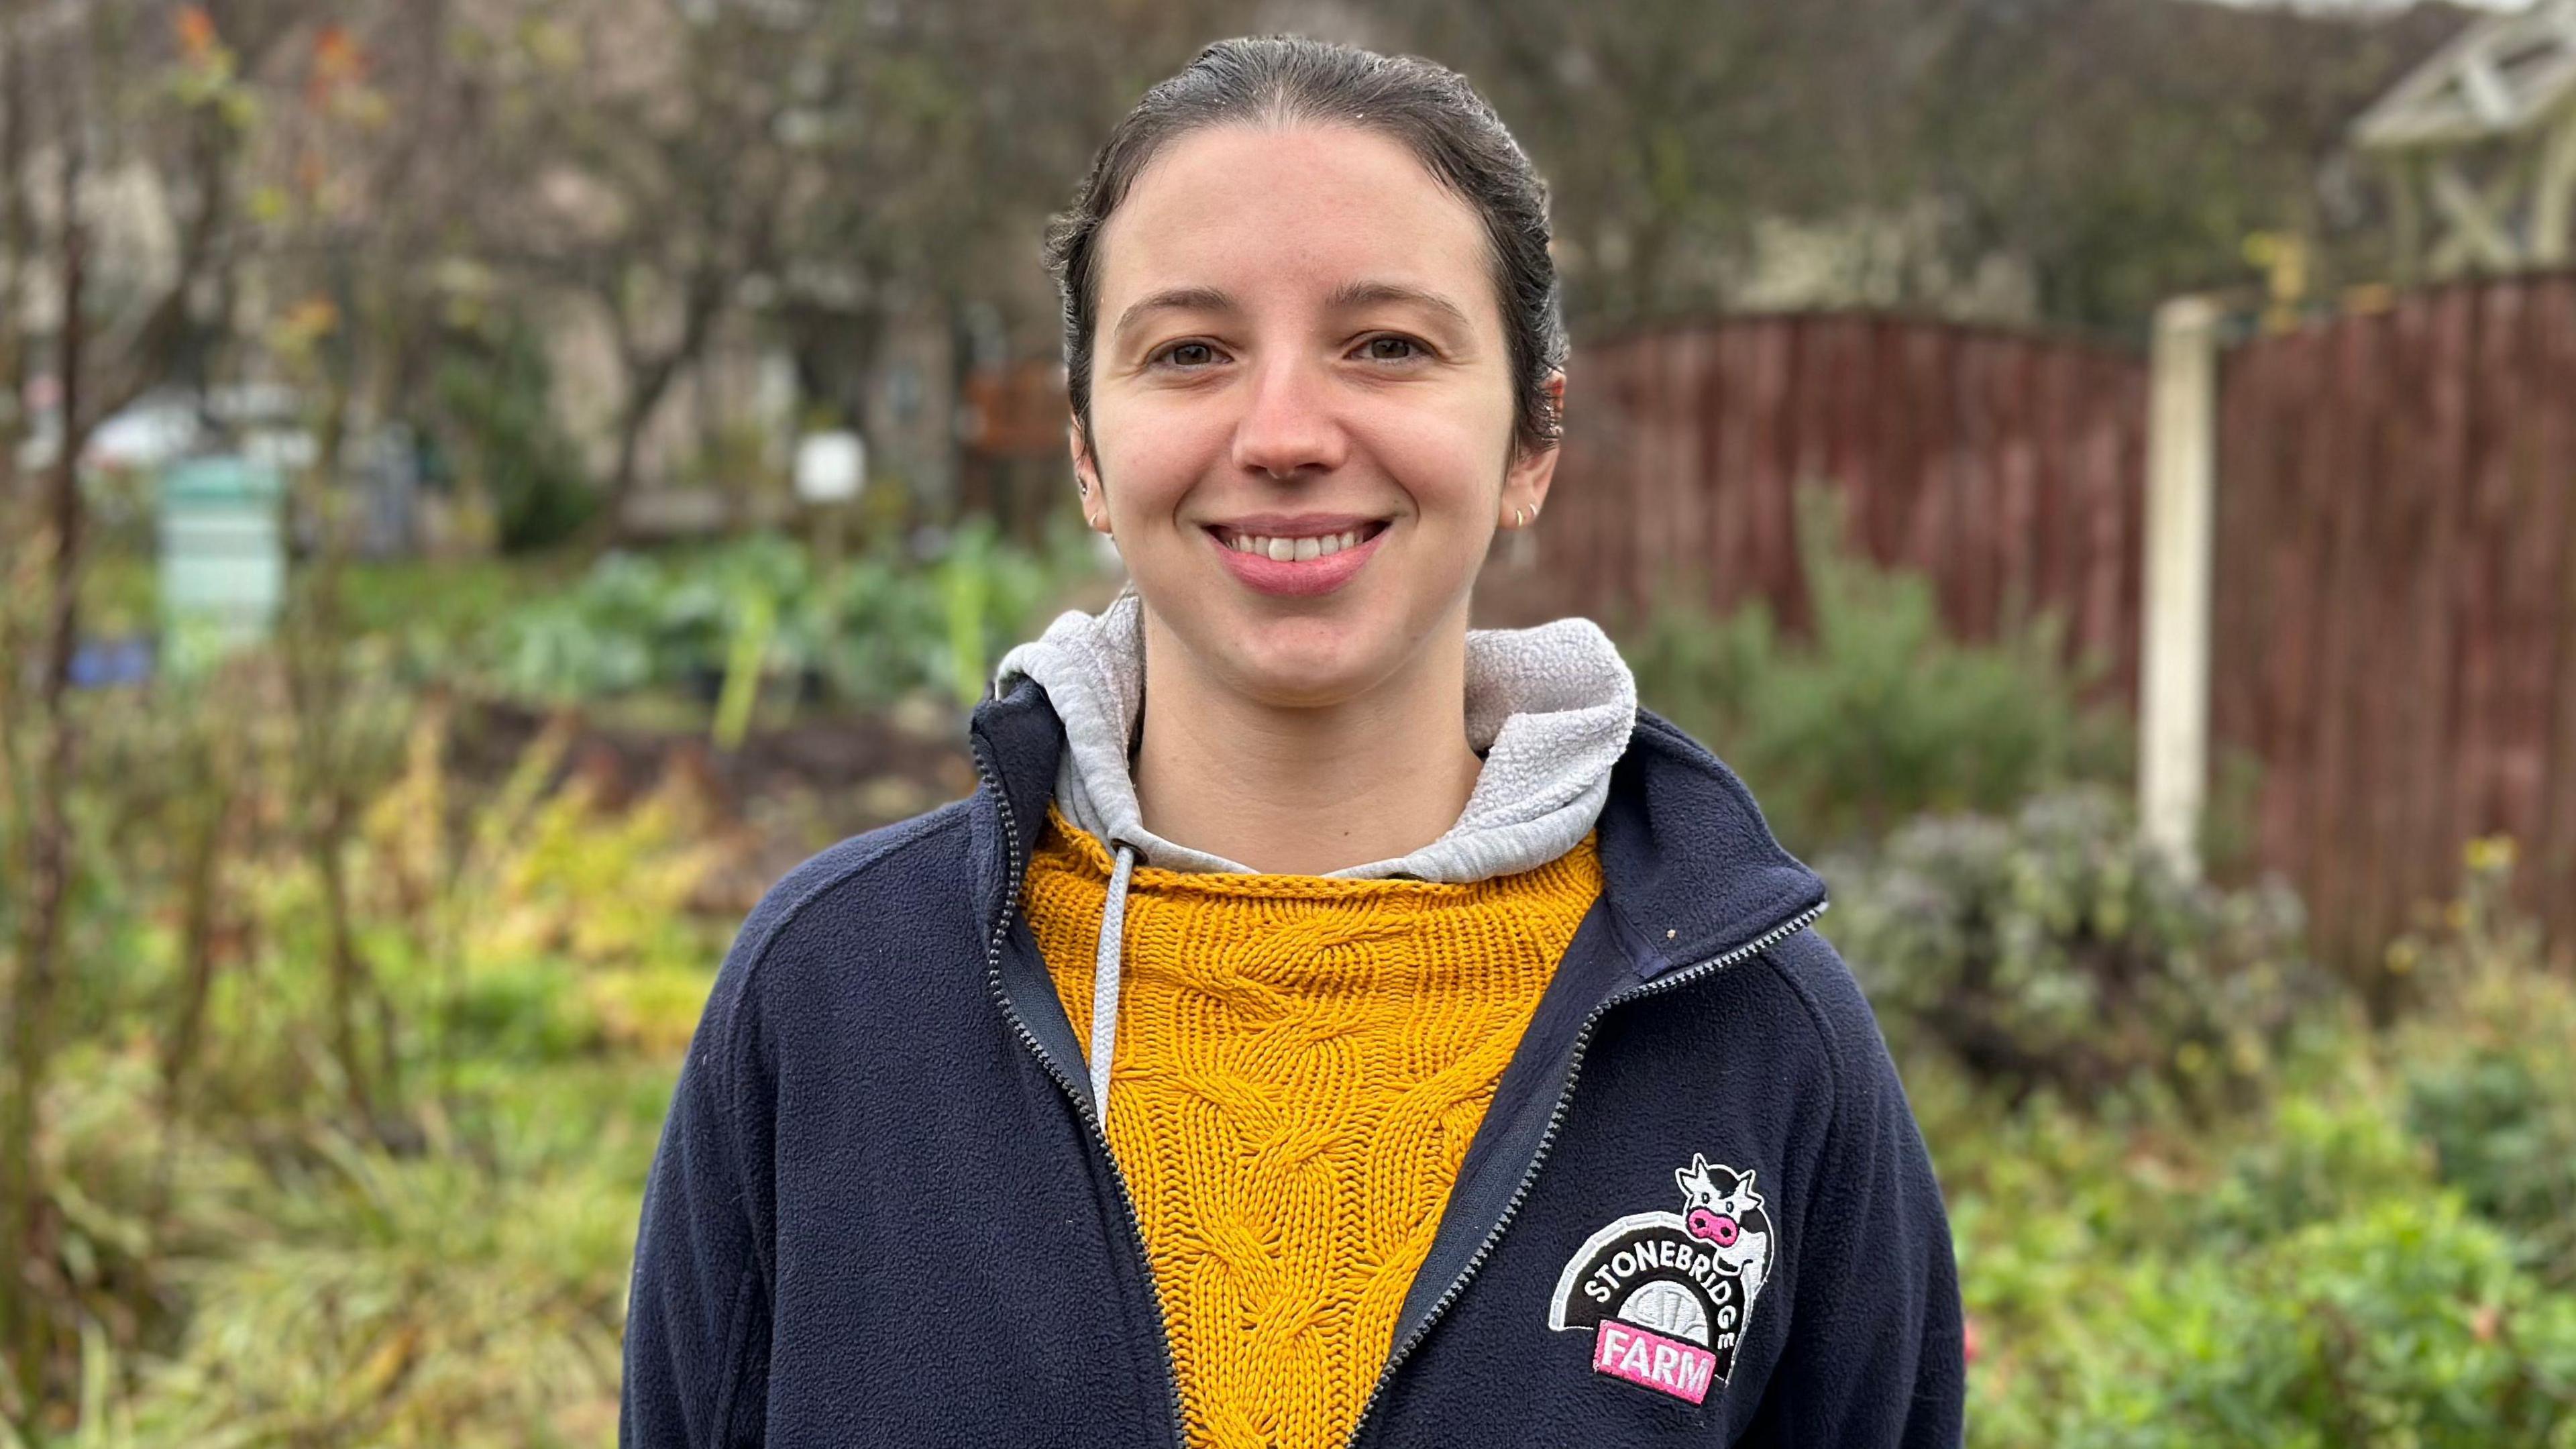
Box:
(1548, 1152), (1772, 1403)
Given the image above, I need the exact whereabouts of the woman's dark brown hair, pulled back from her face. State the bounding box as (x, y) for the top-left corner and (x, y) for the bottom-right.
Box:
(1046, 36), (1566, 451)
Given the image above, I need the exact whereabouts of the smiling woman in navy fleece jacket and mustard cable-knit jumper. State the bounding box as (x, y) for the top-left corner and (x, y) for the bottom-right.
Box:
(623, 39), (1963, 1446)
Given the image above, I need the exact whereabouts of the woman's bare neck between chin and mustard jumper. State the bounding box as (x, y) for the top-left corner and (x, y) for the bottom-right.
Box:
(1136, 598), (1484, 877)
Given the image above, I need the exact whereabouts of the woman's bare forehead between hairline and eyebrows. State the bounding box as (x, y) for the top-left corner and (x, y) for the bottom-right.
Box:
(1097, 123), (1499, 325)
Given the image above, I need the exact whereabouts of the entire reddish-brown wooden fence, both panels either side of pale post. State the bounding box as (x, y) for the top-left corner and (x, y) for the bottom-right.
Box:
(1489, 287), (2576, 962)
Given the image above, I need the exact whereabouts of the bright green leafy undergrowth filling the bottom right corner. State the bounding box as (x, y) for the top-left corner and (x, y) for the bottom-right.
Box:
(1947, 843), (2576, 1449)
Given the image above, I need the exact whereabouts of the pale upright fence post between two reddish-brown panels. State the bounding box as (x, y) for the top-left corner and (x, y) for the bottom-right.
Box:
(2138, 297), (2220, 877)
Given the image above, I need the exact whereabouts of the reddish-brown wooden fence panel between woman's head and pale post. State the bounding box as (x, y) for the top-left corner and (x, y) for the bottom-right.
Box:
(1491, 315), (2146, 699)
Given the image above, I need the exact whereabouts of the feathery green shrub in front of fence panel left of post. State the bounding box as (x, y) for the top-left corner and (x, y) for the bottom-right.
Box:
(1620, 490), (2128, 853)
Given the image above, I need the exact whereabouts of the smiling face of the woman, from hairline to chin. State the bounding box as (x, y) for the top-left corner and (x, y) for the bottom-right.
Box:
(1074, 126), (1561, 706)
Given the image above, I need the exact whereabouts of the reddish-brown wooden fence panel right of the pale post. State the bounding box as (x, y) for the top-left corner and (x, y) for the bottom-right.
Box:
(2210, 276), (2576, 959)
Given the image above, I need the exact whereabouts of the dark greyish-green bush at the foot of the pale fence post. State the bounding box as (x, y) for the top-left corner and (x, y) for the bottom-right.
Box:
(1824, 786), (2324, 1104)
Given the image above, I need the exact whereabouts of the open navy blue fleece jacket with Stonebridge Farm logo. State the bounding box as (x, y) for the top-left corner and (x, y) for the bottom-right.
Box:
(621, 681), (1966, 1446)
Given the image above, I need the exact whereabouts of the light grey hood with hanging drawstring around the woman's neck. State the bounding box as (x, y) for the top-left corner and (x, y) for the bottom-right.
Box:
(994, 585), (1635, 1122)
